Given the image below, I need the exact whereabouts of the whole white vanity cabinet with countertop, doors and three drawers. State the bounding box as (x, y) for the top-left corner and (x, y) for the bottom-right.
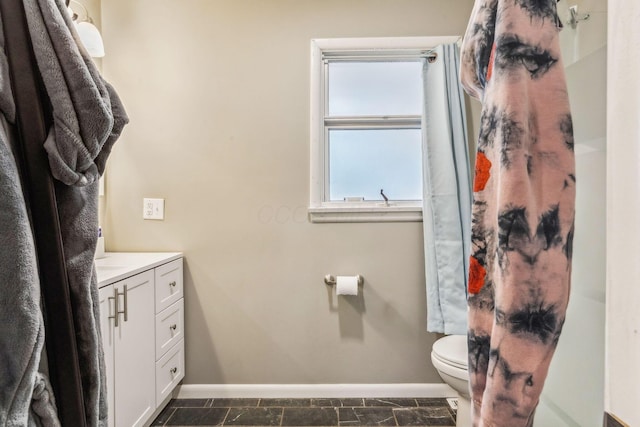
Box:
(96, 253), (184, 427)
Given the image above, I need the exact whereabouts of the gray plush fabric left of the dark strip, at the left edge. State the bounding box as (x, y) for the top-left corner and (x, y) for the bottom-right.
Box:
(0, 106), (59, 427)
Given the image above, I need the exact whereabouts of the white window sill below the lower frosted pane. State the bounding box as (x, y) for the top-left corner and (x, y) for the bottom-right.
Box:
(309, 203), (422, 223)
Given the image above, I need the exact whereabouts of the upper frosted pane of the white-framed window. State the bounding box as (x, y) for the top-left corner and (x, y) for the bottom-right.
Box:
(329, 61), (422, 116)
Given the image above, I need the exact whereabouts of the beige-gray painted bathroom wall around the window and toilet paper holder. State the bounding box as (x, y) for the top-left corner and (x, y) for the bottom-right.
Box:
(102, 0), (472, 384)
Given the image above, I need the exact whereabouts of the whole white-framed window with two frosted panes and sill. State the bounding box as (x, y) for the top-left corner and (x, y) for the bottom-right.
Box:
(309, 37), (455, 222)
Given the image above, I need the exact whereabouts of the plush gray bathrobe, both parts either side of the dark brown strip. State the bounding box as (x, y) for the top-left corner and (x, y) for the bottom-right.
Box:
(0, 0), (128, 426)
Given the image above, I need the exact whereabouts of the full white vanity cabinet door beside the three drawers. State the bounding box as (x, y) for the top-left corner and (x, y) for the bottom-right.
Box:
(113, 270), (156, 426)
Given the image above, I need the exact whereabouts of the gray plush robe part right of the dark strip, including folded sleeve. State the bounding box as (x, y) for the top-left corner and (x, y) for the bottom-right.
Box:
(24, 0), (128, 426)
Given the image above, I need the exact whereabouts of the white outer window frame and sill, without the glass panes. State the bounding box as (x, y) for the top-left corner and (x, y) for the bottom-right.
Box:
(309, 36), (459, 222)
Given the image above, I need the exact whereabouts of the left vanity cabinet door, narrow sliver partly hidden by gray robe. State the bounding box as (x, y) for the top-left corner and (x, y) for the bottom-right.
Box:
(98, 285), (115, 427)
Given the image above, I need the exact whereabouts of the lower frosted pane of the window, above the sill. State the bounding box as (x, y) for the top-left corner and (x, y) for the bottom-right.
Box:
(329, 129), (422, 201)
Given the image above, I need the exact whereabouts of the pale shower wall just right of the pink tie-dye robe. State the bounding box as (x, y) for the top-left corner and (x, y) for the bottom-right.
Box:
(535, 0), (607, 427)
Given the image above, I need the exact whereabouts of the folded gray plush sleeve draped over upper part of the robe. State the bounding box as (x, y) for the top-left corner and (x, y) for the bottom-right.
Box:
(24, 0), (128, 186)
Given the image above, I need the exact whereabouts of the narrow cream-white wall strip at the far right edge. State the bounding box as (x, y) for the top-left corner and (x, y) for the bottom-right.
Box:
(605, 0), (640, 426)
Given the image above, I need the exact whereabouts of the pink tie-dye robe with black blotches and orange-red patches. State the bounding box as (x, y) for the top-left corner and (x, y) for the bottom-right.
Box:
(460, 0), (576, 427)
